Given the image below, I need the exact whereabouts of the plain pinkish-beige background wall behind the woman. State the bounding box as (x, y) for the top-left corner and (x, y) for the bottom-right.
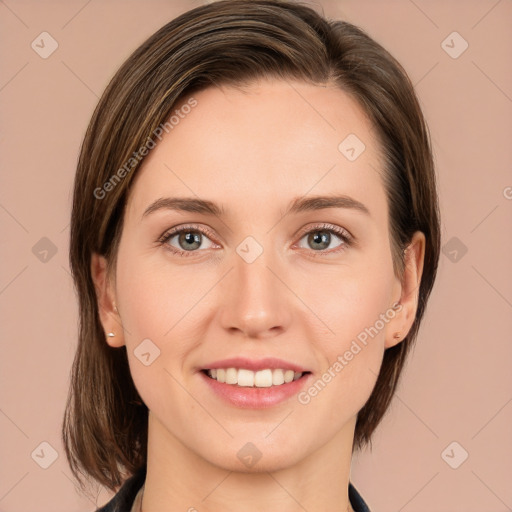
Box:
(0, 0), (512, 512)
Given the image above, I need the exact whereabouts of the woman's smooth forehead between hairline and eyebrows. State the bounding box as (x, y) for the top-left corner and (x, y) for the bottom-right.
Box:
(128, 80), (385, 220)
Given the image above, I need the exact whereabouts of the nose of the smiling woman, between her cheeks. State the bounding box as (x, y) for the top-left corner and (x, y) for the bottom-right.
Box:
(220, 251), (293, 338)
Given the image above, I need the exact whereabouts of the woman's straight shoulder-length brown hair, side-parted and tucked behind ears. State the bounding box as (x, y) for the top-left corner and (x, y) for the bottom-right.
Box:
(62, 0), (440, 496)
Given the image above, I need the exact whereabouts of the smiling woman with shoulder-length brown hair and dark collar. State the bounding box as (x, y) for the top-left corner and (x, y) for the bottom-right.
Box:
(63, 0), (440, 512)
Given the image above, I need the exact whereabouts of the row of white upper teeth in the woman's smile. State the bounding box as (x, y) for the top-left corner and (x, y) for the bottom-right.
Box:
(208, 368), (303, 388)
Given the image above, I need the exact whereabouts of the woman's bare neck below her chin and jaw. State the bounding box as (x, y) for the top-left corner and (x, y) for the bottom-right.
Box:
(141, 413), (355, 512)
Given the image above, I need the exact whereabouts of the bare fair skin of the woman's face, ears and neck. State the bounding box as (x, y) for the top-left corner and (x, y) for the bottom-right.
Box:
(91, 80), (425, 512)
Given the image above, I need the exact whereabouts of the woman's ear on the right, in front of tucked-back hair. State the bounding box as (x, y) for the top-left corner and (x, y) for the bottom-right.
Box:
(385, 231), (425, 348)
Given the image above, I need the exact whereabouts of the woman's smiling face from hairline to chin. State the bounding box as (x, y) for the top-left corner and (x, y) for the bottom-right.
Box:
(95, 81), (420, 471)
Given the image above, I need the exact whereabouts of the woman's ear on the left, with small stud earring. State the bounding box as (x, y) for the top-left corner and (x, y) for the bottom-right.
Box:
(91, 253), (124, 347)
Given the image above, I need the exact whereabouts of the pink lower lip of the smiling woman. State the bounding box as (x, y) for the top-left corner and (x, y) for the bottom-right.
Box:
(199, 372), (312, 409)
